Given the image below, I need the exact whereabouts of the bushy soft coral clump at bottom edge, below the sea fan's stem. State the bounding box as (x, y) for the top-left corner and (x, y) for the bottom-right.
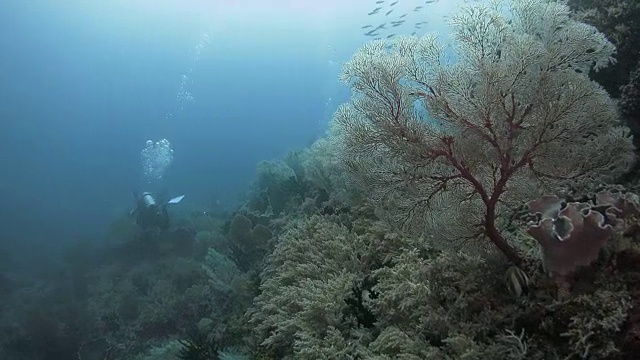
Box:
(369, 246), (527, 360)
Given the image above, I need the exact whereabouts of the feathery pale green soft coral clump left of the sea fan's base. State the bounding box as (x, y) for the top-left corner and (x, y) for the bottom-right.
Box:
(250, 216), (376, 359)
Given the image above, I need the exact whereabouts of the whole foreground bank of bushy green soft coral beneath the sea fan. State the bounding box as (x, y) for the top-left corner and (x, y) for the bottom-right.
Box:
(244, 210), (637, 360)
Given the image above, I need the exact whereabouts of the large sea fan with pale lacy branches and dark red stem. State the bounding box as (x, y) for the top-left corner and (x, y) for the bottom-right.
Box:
(333, 0), (634, 265)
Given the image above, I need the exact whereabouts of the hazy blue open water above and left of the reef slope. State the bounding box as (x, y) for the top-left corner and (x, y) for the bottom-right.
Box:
(0, 0), (460, 262)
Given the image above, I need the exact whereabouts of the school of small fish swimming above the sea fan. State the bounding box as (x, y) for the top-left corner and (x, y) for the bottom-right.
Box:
(361, 0), (439, 40)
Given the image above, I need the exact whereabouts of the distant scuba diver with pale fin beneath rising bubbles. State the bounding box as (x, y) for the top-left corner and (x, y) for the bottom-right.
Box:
(131, 192), (184, 230)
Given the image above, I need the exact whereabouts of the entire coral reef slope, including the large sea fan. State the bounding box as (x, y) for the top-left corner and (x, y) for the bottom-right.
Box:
(0, 0), (640, 360)
